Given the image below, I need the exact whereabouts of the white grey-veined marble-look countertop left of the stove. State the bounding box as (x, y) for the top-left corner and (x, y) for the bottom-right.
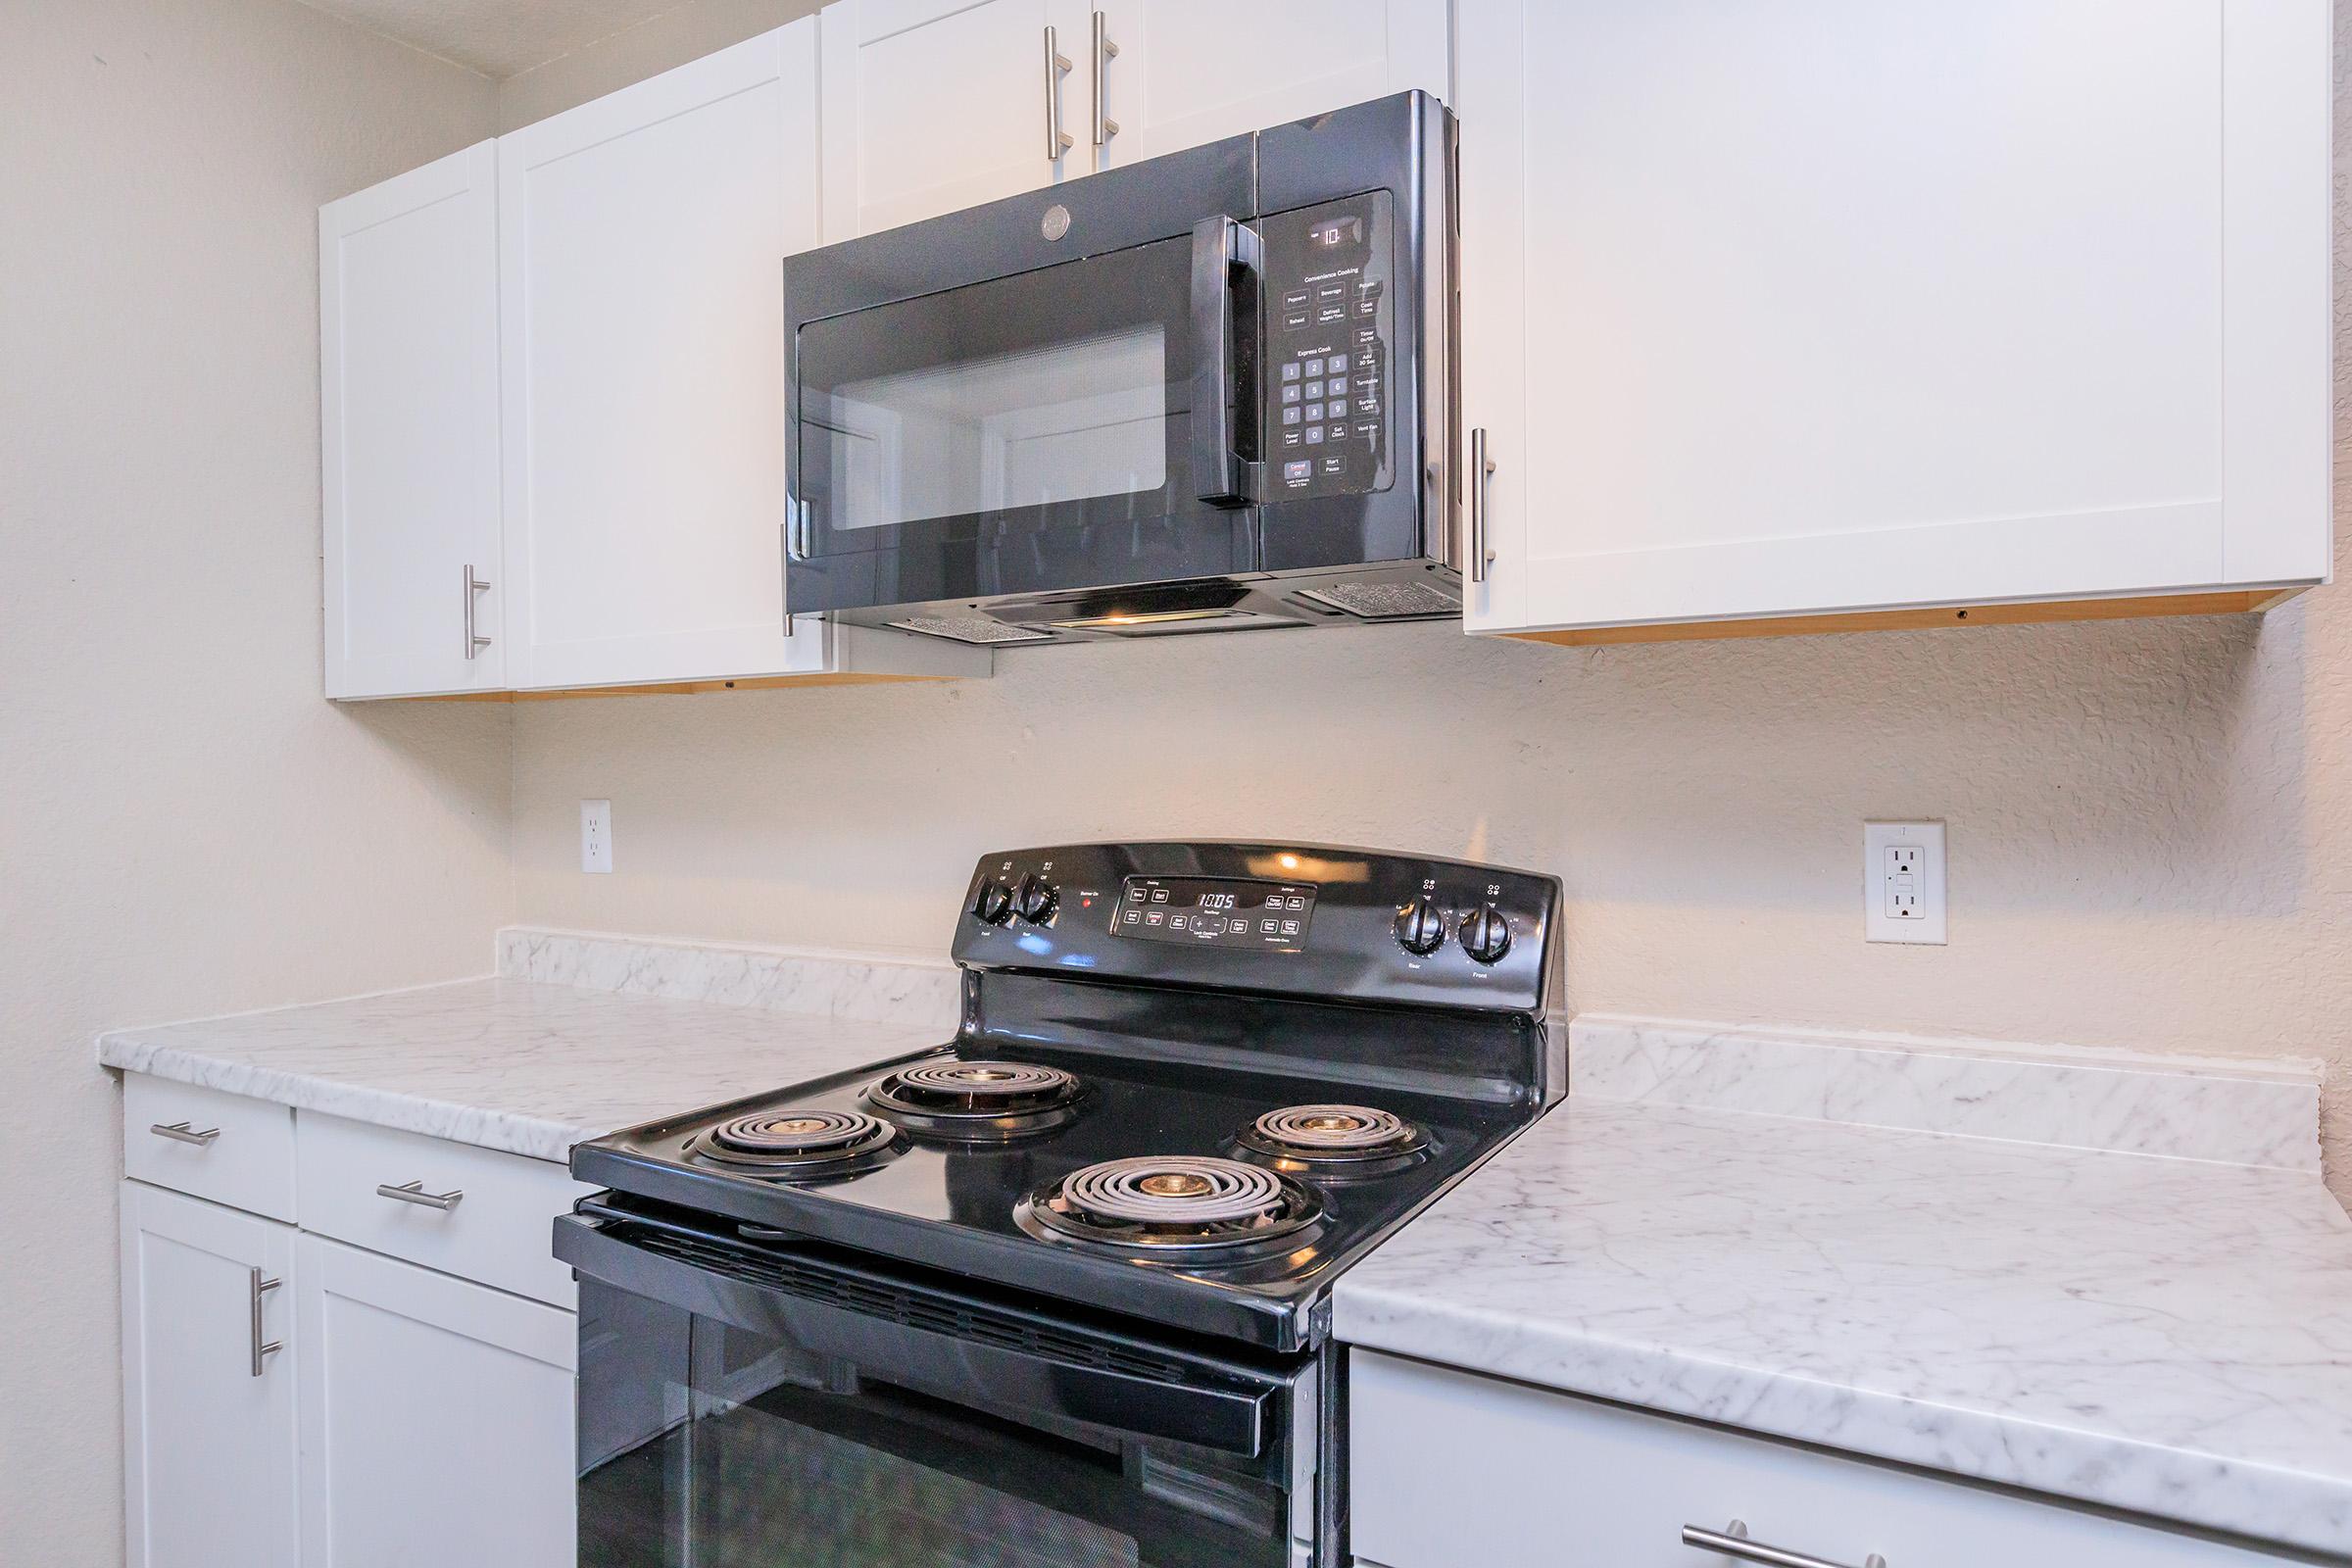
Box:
(99, 980), (953, 1159)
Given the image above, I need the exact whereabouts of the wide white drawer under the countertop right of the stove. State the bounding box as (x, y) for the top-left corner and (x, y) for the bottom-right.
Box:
(1348, 1351), (2281, 1568)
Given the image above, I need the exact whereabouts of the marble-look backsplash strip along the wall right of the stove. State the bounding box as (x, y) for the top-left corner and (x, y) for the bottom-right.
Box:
(1569, 1013), (2322, 1175)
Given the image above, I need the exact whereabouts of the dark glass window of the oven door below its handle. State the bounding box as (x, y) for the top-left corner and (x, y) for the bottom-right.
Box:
(578, 1279), (1298, 1568)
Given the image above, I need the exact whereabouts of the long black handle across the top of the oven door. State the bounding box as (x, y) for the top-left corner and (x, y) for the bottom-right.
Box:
(555, 1199), (1275, 1455)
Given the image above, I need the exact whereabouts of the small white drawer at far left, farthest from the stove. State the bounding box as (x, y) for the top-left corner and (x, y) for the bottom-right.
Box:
(122, 1072), (294, 1222)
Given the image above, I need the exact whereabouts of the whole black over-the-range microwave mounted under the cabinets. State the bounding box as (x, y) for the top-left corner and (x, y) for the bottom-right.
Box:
(783, 92), (1463, 644)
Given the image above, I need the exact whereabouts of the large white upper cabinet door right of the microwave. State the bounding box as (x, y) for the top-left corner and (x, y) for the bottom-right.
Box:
(1456, 0), (2330, 630)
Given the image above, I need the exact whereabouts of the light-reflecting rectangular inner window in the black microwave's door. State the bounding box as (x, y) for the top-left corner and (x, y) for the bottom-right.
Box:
(805, 322), (1169, 529)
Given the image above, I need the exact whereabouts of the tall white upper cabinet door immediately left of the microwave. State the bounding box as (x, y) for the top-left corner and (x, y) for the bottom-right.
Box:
(499, 19), (825, 689)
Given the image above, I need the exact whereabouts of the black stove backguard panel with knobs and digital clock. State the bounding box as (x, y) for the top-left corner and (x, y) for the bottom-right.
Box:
(955, 842), (1559, 1013)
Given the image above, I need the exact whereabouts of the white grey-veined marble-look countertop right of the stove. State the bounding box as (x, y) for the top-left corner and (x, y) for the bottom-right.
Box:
(1336, 1098), (2352, 1551)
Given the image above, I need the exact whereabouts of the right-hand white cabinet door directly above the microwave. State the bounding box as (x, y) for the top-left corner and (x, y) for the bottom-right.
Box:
(1080, 0), (1451, 165)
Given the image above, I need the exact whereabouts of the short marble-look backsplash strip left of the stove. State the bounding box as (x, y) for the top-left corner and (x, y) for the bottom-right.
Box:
(499, 926), (962, 1037)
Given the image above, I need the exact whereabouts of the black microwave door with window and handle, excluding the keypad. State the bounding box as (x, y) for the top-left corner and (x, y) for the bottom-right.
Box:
(788, 219), (1258, 612)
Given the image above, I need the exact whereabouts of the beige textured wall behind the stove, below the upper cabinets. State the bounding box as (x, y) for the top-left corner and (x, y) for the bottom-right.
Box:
(501, 0), (2352, 1197)
